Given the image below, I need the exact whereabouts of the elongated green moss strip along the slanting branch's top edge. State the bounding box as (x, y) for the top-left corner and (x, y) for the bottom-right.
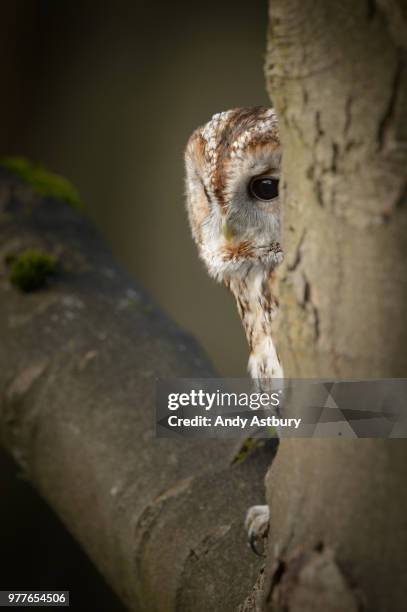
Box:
(0, 157), (84, 210)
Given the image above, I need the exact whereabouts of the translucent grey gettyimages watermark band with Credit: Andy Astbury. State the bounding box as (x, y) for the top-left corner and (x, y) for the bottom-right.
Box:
(156, 378), (407, 438)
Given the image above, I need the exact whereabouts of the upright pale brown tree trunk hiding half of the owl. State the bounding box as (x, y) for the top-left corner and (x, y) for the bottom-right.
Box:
(241, 0), (407, 612)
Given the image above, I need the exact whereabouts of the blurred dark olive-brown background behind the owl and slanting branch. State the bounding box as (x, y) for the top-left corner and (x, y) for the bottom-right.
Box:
(0, 0), (269, 611)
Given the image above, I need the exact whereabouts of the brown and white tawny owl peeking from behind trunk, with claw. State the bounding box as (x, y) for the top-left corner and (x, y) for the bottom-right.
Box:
(185, 107), (283, 552)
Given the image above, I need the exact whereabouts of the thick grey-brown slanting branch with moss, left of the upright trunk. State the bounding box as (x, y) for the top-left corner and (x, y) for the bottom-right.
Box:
(0, 173), (270, 612)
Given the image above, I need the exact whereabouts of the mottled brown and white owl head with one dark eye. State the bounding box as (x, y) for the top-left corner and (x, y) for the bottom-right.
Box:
(185, 107), (282, 283)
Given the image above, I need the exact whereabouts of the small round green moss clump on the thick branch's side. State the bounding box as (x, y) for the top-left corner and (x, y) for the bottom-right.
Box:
(9, 249), (58, 292)
